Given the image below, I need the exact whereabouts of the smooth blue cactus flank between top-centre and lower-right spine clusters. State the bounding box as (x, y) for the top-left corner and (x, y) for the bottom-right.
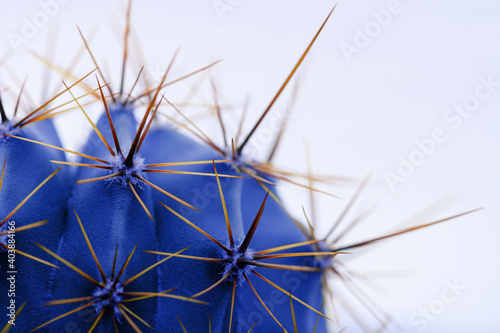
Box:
(144, 128), (243, 332)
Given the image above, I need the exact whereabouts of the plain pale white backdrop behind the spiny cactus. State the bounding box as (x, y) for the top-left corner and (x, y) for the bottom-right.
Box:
(0, 0), (500, 333)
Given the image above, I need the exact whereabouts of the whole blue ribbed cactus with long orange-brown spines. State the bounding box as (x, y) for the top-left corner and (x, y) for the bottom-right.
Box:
(0, 3), (480, 333)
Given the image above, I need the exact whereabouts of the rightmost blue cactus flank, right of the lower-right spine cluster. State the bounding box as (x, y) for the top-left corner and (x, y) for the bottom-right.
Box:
(236, 175), (325, 332)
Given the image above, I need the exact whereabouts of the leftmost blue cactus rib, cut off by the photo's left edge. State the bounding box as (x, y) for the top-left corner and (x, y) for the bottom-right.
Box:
(0, 120), (72, 332)
